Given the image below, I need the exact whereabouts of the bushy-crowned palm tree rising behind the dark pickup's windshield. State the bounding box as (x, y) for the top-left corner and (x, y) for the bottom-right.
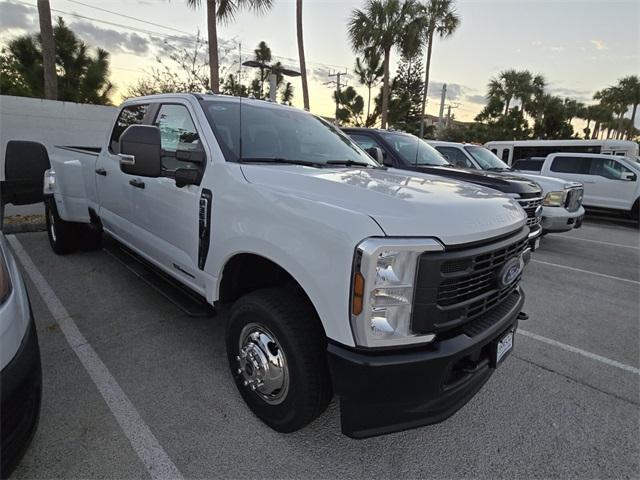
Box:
(348, 0), (417, 128)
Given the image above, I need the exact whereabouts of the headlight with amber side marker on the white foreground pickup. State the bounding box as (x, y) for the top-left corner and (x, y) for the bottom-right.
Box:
(351, 238), (444, 347)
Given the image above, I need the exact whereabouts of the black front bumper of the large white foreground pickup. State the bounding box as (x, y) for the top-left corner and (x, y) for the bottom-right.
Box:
(328, 290), (524, 438)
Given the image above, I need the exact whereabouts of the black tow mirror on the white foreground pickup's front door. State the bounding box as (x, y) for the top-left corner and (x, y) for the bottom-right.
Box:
(119, 125), (162, 177)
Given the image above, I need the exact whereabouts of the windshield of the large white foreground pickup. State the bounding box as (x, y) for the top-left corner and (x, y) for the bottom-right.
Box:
(202, 98), (380, 167)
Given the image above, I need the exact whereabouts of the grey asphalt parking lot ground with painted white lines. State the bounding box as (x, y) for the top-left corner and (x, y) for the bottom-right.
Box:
(6, 220), (640, 478)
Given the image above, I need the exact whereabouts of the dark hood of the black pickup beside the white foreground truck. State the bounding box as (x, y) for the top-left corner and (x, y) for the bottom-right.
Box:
(402, 165), (542, 197)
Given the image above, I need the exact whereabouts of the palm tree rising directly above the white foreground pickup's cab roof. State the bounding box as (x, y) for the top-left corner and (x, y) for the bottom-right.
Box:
(187, 0), (273, 93)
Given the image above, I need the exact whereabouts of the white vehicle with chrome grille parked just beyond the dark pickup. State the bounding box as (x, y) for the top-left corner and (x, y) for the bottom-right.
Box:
(429, 141), (584, 233)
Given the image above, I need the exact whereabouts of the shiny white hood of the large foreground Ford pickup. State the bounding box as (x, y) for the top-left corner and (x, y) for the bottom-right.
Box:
(242, 165), (526, 245)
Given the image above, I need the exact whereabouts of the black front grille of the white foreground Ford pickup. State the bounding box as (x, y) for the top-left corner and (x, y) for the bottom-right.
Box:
(412, 229), (528, 333)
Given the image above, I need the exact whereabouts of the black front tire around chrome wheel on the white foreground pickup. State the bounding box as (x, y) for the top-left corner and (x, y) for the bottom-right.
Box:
(226, 288), (332, 433)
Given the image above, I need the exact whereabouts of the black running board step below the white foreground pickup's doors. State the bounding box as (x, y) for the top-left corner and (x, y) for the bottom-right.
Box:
(104, 238), (215, 317)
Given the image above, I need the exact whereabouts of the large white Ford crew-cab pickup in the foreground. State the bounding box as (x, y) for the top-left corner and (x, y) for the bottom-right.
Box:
(11, 94), (530, 438)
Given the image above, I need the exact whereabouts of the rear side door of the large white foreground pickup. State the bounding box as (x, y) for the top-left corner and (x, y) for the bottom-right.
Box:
(94, 103), (150, 244)
